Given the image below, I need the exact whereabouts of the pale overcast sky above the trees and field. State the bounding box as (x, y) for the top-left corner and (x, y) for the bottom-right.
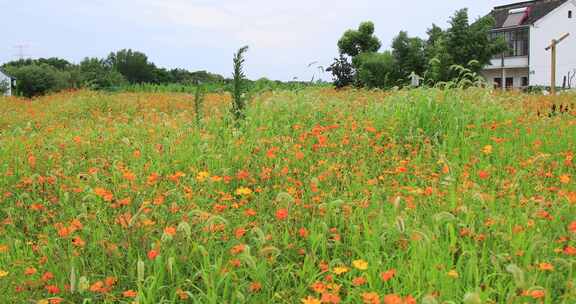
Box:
(0, 0), (517, 80)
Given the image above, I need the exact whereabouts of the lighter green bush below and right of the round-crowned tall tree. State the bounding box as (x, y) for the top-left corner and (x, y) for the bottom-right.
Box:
(358, 51), (396, 89)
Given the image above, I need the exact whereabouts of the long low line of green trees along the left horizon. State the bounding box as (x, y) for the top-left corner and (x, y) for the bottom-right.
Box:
(2, 49), (224, 97)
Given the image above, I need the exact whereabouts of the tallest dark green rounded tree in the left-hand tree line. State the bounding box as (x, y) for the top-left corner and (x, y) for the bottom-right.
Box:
(106, 49), (157, 83)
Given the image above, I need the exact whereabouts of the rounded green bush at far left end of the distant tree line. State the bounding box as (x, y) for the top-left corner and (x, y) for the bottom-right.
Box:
(7, 64), (70, 97)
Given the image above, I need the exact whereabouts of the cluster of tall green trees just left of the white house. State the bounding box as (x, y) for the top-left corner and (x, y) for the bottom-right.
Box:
(327, 9), (507, 89)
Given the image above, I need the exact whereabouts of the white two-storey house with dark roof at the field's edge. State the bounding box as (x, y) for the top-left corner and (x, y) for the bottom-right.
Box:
(482, 0), (576, 88)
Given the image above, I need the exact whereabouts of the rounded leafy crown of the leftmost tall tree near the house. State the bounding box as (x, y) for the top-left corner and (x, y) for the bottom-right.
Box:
(338, 21), (382, 57)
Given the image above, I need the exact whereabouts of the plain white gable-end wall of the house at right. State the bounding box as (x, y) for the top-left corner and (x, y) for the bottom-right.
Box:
(530, 0), (576, 86)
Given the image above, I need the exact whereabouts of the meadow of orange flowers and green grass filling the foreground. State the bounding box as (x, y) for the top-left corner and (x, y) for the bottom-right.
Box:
(0, 88), (576, 304)
